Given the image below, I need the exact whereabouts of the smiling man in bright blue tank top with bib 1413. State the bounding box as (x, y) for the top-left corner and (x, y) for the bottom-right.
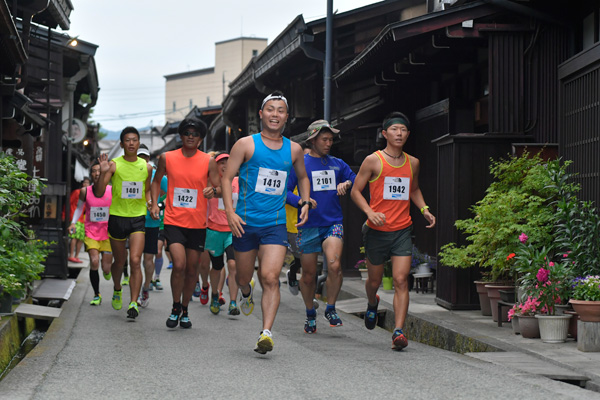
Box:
(221, 92), (311, 354)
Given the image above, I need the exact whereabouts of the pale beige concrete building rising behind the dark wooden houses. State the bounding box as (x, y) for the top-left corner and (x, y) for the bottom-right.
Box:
(165, 37), (267, 123)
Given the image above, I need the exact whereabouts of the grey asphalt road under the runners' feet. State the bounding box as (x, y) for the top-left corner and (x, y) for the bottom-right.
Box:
(0, 270), (598, 400)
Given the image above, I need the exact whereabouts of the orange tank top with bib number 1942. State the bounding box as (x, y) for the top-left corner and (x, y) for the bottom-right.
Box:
(367, 151), (413, 232)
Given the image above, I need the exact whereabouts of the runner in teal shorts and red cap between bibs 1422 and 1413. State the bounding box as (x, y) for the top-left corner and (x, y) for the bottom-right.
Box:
(204, 152), (240, 315)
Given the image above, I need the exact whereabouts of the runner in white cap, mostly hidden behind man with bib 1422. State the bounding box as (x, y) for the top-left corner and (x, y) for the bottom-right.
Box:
(138, 144), (167, 308)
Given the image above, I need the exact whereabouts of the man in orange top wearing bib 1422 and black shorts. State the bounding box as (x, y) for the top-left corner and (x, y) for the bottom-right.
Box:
(151, 118), (220, 328)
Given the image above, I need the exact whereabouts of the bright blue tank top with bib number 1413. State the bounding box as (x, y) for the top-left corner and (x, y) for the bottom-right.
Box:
(235, 133), (292, 227)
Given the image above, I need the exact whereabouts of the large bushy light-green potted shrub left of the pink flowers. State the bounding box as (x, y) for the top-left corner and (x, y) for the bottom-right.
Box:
(439, 153), (557, 314)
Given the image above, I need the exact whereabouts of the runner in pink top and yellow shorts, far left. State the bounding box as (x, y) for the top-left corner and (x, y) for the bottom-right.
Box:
(69, 160), (112, 306)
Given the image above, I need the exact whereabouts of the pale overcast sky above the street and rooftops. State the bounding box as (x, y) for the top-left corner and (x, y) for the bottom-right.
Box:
(61, 0), (377, 131)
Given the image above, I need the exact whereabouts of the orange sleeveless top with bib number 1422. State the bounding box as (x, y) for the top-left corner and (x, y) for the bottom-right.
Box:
(165, 149), (210, 229)
